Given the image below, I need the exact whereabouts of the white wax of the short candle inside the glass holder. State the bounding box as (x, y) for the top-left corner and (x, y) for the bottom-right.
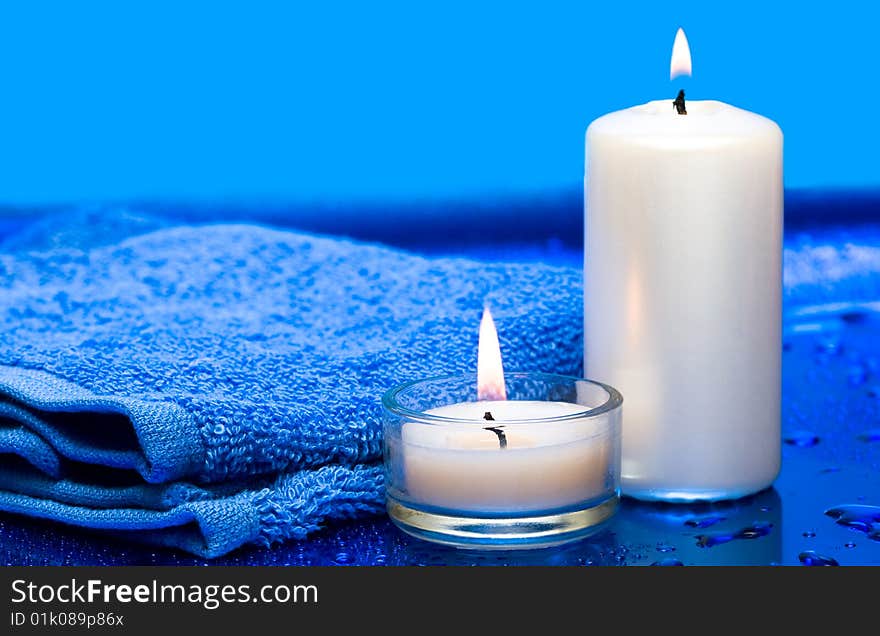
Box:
(401, 400), (616, 513)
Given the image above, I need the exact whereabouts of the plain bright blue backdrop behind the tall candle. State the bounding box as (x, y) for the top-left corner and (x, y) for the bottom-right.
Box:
(0, 0), (880, 206)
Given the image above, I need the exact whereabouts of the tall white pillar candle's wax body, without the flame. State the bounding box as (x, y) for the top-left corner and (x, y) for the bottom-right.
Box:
(584, 99), (783, 500)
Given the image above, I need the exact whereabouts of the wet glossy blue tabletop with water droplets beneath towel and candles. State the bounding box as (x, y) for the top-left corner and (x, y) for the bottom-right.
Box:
(0, 200), (880, 565)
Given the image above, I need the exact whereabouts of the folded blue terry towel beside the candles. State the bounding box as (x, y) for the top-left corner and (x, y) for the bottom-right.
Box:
(0, 212), (582, 557)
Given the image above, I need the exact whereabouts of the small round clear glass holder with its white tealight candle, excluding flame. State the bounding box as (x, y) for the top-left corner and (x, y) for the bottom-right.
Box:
(382, 373), (623, 549)
